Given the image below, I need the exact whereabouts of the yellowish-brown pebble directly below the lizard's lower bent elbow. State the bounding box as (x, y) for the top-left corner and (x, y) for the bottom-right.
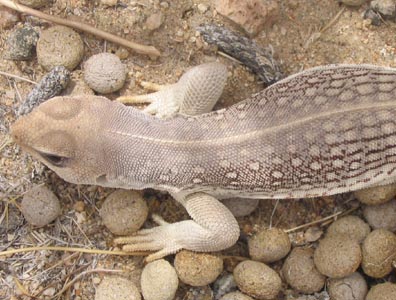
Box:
(174, 250), (223, 286)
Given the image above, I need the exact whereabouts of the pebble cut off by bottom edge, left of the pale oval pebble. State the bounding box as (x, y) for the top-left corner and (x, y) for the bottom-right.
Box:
(95, 276), (142, 300)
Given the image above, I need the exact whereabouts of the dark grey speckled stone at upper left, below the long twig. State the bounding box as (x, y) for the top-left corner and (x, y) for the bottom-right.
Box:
(4, 26), (39, 60)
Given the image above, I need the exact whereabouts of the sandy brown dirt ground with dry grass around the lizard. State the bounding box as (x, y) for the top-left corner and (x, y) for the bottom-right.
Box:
(0, 0), (396, 299)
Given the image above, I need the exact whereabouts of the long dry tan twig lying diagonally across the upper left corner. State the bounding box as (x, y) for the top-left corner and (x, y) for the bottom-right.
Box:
(0, 0), (161, 58)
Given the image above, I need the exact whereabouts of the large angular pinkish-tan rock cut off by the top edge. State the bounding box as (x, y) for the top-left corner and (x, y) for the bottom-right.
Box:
(215, 0), (279, 37)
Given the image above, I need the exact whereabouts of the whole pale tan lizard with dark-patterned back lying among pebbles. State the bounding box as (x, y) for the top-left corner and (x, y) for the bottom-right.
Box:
(11, 63), (396, 261)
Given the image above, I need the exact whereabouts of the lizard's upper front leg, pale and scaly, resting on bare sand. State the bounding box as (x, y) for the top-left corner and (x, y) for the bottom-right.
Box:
(117, 63), (227, 118)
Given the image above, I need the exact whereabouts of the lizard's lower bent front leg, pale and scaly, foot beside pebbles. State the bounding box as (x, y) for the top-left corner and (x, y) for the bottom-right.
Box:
(114, 193), (239, 261)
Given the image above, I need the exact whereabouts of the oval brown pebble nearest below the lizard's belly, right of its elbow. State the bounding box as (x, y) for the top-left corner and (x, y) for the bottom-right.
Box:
(249, 228), (291, 263)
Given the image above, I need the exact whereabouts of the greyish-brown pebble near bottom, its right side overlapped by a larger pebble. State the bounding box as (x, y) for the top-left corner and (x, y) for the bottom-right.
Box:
(282, 247), (326, 294)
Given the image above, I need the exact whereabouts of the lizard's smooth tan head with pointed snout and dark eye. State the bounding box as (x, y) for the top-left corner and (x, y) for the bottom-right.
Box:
(11, 96), (111, 184)
